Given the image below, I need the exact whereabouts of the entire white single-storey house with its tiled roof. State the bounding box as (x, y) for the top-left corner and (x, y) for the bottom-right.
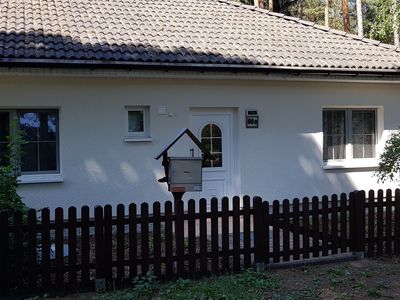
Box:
(0, 0), (400, 208)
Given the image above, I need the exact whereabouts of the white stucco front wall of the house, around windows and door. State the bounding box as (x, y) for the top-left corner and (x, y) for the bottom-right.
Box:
(0, 70), (400, 212)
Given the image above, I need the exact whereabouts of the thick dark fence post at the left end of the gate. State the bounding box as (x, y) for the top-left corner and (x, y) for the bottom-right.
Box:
(253, 197), (267, 272)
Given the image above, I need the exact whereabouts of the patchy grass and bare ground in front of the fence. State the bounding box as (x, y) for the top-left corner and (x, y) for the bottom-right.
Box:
(60, 257), (400, 300)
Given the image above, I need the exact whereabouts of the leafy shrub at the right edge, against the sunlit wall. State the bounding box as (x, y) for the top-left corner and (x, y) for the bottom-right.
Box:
(376, 130), (400, 182)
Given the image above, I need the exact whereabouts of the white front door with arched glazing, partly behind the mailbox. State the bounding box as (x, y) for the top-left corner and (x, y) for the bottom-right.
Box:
(190, 110), (233, 200)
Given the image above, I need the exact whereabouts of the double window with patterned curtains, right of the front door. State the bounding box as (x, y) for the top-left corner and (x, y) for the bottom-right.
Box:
(323, 109), (377, 161)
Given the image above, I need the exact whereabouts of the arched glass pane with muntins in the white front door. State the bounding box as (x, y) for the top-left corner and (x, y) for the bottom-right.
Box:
(201, 123), (222, 168)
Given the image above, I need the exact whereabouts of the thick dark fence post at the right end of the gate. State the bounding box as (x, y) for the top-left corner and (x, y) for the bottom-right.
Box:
(350, 191), (365, 258)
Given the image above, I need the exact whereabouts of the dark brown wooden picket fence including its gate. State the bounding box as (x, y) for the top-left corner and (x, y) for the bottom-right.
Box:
(0, 190), (400, 295)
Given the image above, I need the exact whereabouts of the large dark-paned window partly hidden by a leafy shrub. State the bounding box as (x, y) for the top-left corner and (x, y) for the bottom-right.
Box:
(0, 109), (60, 175)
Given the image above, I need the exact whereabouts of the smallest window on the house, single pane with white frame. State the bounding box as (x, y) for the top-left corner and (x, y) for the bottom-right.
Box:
(126, 106), (150, 138)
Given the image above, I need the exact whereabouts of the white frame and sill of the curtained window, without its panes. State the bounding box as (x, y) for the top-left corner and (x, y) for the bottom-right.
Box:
(321, 106), (383, 170)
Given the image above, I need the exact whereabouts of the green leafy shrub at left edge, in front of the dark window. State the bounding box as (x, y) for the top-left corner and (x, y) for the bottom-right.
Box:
(0, 120), (27, 214)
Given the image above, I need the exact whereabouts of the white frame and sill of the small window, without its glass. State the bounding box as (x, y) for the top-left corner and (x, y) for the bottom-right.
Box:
(124, 106), (152, 142)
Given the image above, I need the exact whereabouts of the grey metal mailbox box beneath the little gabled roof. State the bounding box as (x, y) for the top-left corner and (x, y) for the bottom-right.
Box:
(168, 157), (203, 193)
